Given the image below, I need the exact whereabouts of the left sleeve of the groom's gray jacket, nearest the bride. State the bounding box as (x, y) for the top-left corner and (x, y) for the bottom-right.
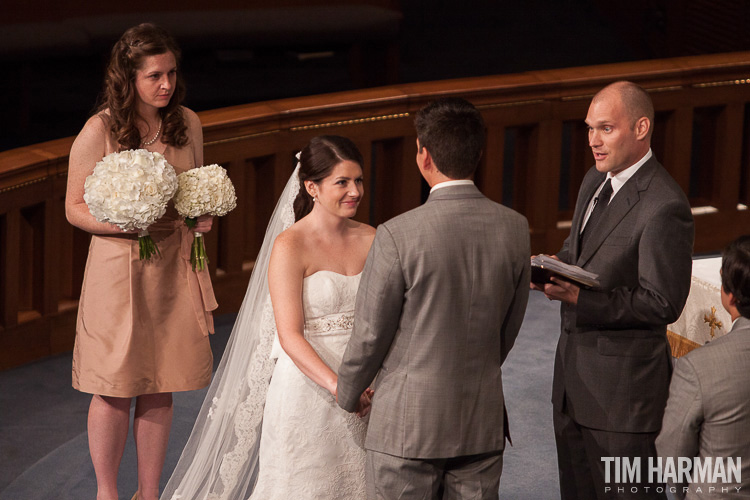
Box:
(337, 225), (406, 412)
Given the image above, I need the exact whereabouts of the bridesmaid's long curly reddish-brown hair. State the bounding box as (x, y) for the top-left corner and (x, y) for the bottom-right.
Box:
(97, 23), (188, 149)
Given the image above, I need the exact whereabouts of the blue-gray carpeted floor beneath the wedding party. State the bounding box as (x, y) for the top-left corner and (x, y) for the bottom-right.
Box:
(0, 292), (559, 500)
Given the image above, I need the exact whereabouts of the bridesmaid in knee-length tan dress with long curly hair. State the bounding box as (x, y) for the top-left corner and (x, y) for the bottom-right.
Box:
(65, 24), (216, 500)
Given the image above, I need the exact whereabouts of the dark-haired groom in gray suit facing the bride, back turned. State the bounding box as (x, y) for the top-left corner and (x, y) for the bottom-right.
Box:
(337, 98), (529, 500)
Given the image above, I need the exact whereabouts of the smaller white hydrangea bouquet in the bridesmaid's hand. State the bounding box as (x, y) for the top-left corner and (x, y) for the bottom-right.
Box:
(174, 164), (237, 271)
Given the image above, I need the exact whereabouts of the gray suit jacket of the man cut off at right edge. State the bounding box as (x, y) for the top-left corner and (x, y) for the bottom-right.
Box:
(656, 317), (750, 499)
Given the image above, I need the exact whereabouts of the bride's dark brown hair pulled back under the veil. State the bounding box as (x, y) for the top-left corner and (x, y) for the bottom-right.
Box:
(294, 135), (363, 221)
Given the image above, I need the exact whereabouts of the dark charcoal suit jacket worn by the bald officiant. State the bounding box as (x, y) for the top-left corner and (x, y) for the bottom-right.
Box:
(552, 156), (694, 432)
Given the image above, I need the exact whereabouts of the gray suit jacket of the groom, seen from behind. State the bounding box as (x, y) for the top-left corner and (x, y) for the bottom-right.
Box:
(338, 185), (530, 458)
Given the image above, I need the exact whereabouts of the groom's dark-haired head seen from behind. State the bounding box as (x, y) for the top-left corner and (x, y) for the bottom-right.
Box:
(414, 97), (486, 179)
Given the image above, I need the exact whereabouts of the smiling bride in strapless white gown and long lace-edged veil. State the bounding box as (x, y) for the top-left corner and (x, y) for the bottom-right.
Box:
(162, 136), (375, 500)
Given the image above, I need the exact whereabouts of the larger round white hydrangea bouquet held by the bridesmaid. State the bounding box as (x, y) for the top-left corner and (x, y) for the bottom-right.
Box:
(83, 149), (177, 260)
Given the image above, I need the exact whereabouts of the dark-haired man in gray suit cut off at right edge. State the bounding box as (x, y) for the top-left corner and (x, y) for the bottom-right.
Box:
(656, 236), (750, 500)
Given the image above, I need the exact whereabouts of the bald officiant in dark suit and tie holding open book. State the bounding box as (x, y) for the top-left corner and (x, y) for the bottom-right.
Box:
(544, 82), (694, 500)
